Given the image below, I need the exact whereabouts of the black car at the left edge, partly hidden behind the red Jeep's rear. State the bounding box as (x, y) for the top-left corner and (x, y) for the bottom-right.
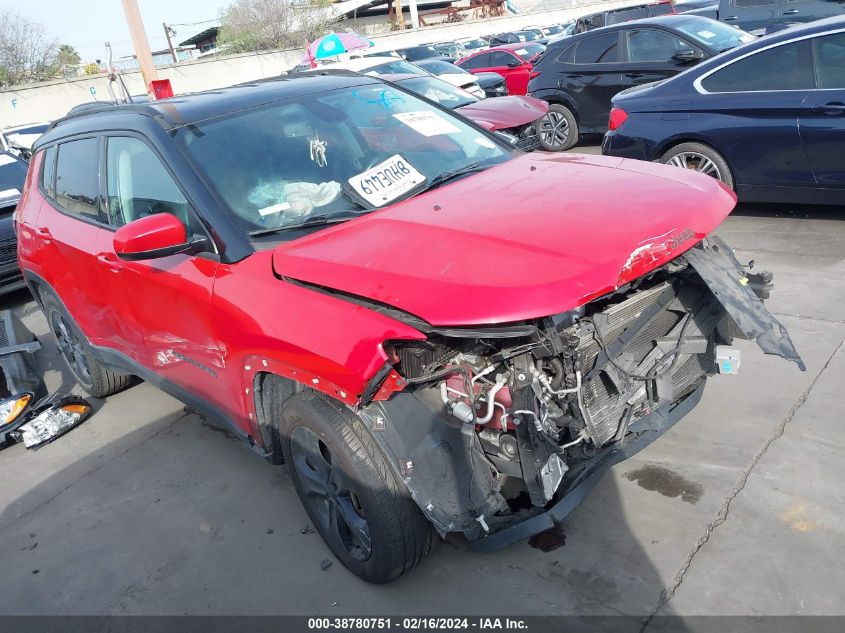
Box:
(0, 151), (27, 294)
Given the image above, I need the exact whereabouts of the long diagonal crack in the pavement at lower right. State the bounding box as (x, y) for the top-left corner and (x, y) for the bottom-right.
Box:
(640, 338), (845, 633)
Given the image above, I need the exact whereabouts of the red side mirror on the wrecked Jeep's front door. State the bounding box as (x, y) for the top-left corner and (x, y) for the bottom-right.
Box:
(113, 213), (208, 261)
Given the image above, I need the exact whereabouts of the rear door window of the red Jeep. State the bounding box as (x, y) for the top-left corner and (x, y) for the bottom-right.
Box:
(56, 138), (100, 219)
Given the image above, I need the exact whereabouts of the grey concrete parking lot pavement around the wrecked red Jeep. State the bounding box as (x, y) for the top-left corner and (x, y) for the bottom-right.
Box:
(0, 139), (845, 630)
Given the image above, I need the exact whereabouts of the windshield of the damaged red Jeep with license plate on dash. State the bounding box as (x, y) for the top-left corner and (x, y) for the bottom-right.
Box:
(175, 83), (512, 233)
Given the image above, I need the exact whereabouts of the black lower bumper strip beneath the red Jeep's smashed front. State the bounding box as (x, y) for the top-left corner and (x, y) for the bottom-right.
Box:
(471, 382), (705, 552)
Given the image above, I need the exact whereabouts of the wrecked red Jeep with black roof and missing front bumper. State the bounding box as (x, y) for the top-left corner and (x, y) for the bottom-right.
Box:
(16, 74), (801, 582)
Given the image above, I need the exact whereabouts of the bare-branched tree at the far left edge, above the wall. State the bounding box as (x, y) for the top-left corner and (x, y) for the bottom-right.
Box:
(0, 10), (58, 86)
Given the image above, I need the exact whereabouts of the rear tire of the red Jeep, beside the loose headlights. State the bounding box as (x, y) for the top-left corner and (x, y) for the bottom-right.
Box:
(42, 292), (132, 398)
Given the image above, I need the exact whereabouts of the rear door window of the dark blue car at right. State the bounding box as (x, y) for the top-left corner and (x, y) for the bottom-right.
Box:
(701, 40), (813, 92)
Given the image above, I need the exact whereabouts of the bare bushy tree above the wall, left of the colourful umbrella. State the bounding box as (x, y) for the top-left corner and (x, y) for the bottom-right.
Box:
(217, 0), (337, 53)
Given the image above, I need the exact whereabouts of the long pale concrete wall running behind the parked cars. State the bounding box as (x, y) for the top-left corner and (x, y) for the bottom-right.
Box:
(0, 0), (643, 127)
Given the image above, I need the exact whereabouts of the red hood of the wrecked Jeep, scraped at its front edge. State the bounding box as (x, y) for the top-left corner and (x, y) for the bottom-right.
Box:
(273, 153), (736, 327)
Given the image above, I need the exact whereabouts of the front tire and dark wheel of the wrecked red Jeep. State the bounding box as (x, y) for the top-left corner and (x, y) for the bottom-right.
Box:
(279, 391), (432, 584)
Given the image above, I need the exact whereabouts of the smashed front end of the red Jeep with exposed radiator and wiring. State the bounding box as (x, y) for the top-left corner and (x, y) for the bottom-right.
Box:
(361, 238), (803, 549)
